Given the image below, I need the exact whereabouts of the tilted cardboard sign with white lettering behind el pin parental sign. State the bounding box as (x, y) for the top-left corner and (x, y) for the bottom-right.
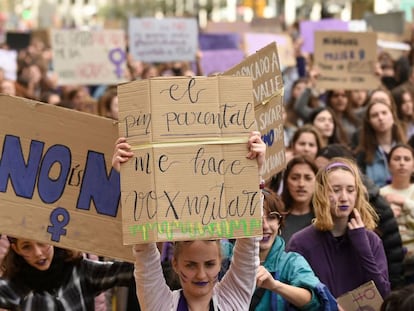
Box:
(224, 42), (286, 179)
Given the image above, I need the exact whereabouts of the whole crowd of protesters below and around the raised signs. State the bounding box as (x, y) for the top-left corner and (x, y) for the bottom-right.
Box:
(0, 14), (414, 311)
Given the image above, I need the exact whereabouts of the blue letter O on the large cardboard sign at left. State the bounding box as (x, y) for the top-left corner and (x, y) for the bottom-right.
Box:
(37, 145), (72, 204)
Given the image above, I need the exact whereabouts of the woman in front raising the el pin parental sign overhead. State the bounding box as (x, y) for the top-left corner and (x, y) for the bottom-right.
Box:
(112, 132), (266, 311)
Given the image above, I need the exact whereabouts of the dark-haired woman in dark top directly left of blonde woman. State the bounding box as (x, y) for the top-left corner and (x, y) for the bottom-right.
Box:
(281, 156), (318, 243)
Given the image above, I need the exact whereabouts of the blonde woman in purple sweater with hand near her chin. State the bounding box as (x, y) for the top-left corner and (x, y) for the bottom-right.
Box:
(287, 158), (390, 297)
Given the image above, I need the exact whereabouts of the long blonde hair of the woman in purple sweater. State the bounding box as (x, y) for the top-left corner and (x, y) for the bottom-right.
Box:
(312, 157), (378, 231)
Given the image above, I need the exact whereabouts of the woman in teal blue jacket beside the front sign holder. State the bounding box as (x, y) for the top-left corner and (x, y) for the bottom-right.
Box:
(250, 188), (338, 311)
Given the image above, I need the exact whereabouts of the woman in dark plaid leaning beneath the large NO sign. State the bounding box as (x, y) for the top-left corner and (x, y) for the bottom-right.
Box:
(0, 236), (134, 311)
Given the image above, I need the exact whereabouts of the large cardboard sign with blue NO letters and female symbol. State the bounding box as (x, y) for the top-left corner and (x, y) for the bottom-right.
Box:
(0, 95), (133, 261)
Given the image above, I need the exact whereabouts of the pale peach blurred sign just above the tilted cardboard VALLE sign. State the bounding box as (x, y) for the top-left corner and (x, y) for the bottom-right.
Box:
(244, 32), (296, 68)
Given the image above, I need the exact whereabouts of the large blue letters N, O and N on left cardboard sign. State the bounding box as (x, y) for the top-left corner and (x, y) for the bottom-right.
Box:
(0, 135), (121, 217)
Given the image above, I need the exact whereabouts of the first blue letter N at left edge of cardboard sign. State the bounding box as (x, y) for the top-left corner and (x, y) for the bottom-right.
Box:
(0, 135), (44, 199)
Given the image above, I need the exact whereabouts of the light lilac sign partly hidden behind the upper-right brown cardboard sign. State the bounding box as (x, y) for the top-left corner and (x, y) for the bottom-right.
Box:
(299, 18), (348, 53)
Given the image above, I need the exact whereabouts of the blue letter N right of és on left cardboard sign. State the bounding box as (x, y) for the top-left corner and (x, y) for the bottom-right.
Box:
(77, 151), (121, 217)
